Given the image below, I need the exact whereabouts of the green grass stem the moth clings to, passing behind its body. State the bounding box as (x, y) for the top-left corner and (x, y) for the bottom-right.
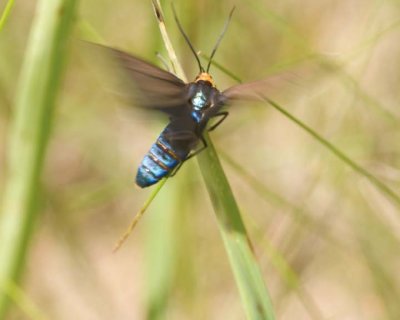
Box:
(153, 0), (274, 320)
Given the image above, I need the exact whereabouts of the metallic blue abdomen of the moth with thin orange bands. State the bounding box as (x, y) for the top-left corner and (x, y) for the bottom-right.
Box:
(136, 134), (183, 188)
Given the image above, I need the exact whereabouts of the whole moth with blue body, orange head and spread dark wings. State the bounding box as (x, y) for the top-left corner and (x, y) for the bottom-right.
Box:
(95, 8), (298, 188)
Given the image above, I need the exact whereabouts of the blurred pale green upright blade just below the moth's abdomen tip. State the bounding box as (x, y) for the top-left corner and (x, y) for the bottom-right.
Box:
(144, 174), (191, 320)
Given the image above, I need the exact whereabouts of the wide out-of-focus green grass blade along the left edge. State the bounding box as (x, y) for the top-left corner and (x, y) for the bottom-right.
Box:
(0, 0), (76, 319)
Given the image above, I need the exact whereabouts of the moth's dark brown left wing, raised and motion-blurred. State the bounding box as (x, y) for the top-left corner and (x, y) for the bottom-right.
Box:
(101, 46), (189, 117)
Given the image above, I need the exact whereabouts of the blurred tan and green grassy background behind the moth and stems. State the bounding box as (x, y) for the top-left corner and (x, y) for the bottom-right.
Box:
(0, 0), (400, 319)
